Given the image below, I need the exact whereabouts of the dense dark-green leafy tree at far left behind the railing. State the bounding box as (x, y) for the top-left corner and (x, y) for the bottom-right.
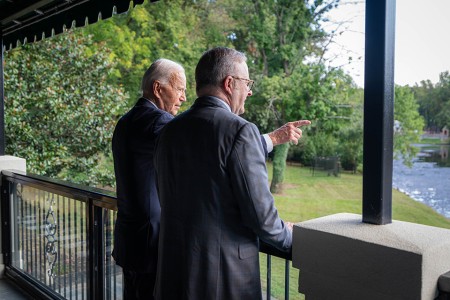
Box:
(5, 32), (126, 185)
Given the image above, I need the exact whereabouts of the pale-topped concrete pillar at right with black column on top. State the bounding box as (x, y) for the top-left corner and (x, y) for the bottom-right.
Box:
(292, 213), (450, 300)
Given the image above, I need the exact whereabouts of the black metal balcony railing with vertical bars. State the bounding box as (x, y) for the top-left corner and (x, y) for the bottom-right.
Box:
(1, 171), (291, 299)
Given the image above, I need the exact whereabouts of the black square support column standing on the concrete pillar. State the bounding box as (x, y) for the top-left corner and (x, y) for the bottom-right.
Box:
(363, 0), (395, 225)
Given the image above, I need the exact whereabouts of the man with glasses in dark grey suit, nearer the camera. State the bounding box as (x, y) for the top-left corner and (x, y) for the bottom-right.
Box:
(154, 47), (310, 300)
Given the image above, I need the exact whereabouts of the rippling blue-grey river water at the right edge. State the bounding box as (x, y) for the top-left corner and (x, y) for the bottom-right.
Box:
(392, 145), (450, 218)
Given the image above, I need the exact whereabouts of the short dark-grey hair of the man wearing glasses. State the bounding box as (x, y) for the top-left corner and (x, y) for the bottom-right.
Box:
(195, 47), (247, 93)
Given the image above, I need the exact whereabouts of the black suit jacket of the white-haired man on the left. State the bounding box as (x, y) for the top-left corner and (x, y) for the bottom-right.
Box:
(112, 98), (173, 273)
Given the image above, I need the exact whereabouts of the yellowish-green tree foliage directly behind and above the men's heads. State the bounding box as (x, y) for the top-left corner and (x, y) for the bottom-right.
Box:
(84, 0), (232, 109)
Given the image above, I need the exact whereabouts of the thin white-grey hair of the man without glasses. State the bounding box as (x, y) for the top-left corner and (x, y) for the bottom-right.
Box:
(141, 58), (185, 96)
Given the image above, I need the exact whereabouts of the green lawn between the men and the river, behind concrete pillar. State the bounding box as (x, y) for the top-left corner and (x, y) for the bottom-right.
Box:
(260, 164), (450, 299)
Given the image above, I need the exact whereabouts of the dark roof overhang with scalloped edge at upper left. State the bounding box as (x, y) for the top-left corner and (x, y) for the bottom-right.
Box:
(0, 0), (157, 49)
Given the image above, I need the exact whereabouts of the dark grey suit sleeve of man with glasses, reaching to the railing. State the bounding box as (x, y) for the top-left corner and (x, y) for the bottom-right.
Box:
(227, 123), (292, 251)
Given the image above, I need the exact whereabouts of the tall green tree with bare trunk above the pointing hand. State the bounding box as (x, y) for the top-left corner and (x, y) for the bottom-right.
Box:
(231, 0), (338, 193)
